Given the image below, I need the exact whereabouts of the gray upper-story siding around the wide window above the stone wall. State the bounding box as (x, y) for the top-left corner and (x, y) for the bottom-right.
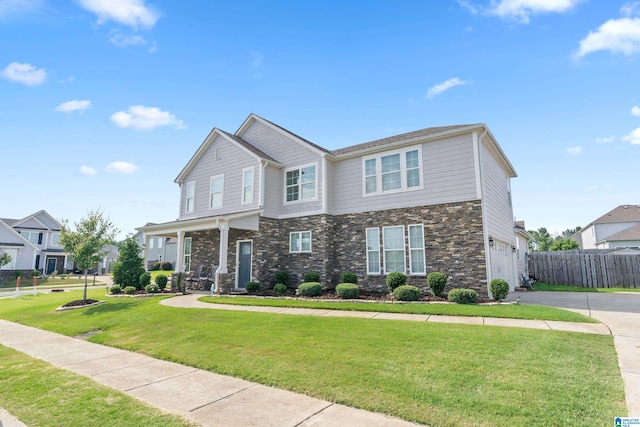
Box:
(329, 134), (477, 215)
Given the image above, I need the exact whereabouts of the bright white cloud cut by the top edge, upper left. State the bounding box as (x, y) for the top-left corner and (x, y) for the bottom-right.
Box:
(77, 0), (160, 29)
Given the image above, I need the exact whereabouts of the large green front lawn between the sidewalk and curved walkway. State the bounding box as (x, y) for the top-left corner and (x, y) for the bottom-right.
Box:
(0, 290), (626, 427)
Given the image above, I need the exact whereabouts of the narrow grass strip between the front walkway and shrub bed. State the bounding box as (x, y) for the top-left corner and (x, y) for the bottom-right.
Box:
(199, 297), (600, 323)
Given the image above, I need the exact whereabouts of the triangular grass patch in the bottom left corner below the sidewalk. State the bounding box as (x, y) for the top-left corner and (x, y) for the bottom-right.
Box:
(0, 345), (194, 427)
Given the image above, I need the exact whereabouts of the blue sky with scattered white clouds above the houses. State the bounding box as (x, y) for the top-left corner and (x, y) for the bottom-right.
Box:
(0, 0), (640, 237)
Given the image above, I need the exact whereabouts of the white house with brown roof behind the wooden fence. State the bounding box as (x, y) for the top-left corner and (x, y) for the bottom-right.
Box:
(571, 205), (640, 249)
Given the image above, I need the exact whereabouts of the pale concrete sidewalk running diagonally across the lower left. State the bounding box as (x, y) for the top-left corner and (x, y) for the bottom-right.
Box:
(0, 320), (417, 427)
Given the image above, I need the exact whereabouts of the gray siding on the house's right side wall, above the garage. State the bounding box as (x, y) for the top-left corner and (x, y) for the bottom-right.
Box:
(480, 143), (515, 244)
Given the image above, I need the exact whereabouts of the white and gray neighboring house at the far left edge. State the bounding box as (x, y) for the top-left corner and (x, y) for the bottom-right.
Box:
(0, 210), (73, 274)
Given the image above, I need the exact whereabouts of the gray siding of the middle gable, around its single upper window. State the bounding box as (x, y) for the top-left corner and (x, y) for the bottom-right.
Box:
(239, 121), (323, 216)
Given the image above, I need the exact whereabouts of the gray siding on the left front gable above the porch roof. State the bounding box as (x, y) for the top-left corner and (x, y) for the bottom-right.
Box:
(180, 136), (260, 218)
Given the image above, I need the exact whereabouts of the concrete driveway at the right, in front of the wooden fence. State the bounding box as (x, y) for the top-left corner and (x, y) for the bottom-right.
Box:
(509, 291), (640, 417)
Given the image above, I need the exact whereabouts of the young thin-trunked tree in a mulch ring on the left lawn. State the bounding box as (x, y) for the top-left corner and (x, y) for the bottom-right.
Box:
(60, 211), (118, 300)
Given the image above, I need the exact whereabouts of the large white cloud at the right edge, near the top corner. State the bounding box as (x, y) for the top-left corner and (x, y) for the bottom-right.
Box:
(574, 17), (640, 58)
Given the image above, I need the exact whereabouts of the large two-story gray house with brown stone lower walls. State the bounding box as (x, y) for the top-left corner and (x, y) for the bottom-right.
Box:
(138, 114), (517, 295)
